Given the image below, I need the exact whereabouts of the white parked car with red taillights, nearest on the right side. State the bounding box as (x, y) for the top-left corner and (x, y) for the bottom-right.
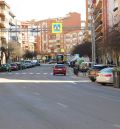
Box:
(96, 68), (113, 85)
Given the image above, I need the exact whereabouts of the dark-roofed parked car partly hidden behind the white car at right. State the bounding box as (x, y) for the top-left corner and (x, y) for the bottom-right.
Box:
(88, 64), (108, 82)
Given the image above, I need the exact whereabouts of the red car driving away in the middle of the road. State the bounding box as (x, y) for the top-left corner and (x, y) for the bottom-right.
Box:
(53, 64), (66, 75)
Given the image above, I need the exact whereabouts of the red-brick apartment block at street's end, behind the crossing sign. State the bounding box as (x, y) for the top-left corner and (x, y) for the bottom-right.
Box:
(31, 12), (81, 57)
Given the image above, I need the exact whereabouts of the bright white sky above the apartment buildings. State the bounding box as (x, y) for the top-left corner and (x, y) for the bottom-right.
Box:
(5, 0), (86, 20)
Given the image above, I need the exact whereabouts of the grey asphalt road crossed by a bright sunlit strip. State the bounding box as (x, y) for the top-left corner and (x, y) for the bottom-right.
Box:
(0, 65), (120, 129)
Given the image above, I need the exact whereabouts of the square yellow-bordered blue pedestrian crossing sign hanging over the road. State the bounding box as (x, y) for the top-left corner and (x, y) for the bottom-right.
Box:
(52, 22), (62, 34)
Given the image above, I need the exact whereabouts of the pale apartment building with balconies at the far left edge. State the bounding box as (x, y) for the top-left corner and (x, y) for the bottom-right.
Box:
(0, 1), (15, 64)
